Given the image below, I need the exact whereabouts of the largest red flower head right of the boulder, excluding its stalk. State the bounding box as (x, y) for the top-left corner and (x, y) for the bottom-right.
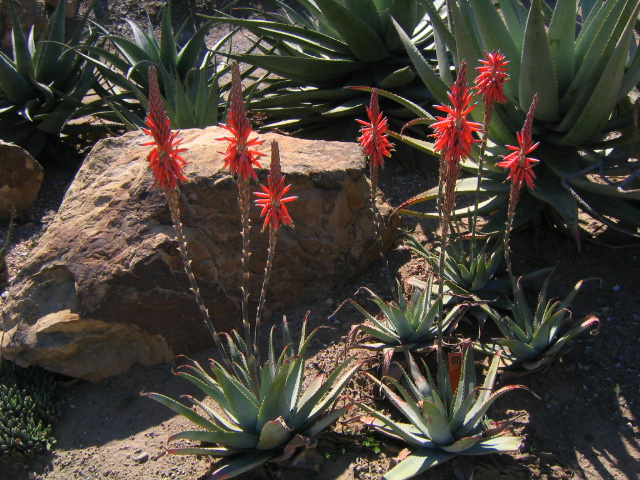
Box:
(431, 62), (482, 163)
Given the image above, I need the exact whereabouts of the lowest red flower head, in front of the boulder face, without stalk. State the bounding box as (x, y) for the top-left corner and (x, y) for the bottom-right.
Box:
(253, 141), (298, 232)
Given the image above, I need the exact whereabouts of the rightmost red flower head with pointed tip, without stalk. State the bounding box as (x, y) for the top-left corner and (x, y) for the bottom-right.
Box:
(496, 93), (540, 189)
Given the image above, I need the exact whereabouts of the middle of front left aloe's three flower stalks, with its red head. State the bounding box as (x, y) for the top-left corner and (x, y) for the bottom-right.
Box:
(218, 62), (264, 345)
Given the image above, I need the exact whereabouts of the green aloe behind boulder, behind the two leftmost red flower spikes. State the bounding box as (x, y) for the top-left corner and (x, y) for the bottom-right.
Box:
(85, 5), (258, 130)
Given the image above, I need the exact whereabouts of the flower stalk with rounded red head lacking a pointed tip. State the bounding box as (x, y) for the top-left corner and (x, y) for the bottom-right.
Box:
(471, 51), (509, 244)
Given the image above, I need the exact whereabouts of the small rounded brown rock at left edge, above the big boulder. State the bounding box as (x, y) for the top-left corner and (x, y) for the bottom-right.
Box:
(0, 140), (44, 219)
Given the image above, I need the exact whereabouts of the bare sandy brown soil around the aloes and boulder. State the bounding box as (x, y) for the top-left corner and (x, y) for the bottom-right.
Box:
(0, 0), (640, 480)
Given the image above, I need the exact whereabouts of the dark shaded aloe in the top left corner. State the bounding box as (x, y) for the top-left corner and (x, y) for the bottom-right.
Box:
(0, 0), (98, 160)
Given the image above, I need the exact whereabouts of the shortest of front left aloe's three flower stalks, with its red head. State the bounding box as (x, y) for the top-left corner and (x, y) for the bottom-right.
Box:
(253, 140), (298, 352)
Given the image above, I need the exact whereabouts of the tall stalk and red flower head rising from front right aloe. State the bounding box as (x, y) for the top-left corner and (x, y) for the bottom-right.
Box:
(431, 61), (482, 376)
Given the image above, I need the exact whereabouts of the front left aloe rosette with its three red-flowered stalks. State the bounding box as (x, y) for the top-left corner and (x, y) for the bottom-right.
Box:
(143, 66), (360, 480)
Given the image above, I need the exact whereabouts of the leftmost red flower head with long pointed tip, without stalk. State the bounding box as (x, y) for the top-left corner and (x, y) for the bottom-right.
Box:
(142, 67), (188, 190)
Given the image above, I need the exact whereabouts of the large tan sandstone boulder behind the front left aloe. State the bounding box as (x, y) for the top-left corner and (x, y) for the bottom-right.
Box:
(2, 127), (397, 381)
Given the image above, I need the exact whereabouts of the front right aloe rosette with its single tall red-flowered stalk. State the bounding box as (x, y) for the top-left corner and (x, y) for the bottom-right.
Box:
(361, 62), (521, 480)
